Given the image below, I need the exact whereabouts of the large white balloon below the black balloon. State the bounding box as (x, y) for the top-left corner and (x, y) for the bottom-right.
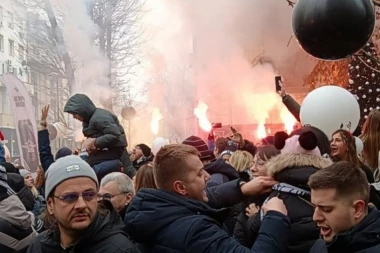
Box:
(300, 85), (360, 137)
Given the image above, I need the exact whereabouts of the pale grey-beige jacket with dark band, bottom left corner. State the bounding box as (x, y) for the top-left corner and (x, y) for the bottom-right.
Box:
(0, 195), (37, 253)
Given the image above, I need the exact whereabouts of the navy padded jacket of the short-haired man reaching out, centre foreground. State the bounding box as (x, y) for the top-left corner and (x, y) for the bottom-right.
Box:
(126, 189), (289, 253)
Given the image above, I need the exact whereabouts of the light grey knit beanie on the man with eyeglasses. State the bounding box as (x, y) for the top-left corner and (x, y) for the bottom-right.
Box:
(45, 155), (99, 200)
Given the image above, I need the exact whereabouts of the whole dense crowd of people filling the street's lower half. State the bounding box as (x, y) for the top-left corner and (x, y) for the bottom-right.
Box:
(0, 90), (380, 253)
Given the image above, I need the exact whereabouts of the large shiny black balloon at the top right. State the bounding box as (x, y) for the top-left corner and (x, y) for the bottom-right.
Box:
(292, 0), (375, 60)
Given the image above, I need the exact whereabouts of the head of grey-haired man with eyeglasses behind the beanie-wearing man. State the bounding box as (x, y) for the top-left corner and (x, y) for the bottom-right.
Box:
(98, 172), (135, 219)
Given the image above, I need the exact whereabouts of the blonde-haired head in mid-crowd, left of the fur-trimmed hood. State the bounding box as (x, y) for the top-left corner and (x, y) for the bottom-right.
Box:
(229, 150), (253, 182)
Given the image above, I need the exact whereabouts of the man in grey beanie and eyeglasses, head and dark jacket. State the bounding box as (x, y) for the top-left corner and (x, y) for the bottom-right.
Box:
(28, 155), (139, 253)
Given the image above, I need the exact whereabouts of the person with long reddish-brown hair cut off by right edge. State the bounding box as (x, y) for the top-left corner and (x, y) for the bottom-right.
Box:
(360, 110), (380, 182)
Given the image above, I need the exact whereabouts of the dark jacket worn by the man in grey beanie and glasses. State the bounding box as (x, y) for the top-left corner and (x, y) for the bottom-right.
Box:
(28, 208), (139, 253)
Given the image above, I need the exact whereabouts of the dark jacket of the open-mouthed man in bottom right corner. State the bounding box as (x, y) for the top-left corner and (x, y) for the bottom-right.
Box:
(310, 207), (380, 253)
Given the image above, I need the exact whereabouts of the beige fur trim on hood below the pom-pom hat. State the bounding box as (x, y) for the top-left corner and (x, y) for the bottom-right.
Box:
(266, 154), (332, 176)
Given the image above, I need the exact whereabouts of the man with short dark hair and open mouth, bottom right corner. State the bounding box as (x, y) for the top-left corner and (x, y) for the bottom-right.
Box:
(309, 162), (380, 253)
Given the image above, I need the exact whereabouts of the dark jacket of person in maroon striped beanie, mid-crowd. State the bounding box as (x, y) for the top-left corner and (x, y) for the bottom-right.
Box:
(205, 158), (239, 187)
